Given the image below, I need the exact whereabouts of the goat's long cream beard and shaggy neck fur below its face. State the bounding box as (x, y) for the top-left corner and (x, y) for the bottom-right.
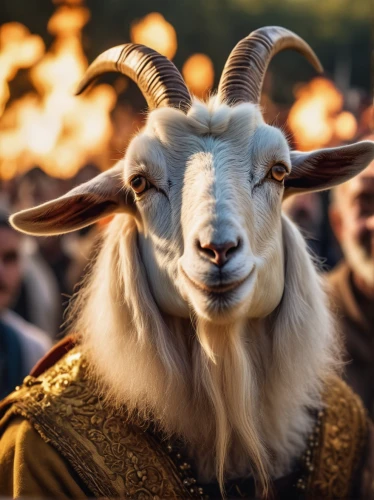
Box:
(70, 215), (339, 489)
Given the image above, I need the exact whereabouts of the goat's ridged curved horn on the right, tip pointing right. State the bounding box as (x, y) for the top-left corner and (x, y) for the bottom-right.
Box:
(218, 26), (323, 104)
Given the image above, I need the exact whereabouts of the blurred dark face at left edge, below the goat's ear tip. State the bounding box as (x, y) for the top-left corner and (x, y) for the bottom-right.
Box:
(0, 226), (22, 312)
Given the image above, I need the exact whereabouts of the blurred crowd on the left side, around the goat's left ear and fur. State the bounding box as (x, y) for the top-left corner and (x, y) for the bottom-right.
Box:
(0, 165), (98, 399)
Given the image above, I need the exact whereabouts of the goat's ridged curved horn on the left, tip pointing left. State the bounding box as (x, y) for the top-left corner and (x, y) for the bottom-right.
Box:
(76, 43), (191, 112)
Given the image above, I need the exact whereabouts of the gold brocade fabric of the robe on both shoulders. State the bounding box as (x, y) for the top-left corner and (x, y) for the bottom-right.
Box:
(0, 347), (366, 499)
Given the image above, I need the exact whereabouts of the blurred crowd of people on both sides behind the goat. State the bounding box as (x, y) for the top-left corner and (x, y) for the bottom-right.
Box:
(0, 152), (374, 416)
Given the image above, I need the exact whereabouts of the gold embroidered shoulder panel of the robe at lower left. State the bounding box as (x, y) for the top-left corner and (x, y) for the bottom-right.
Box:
(1, 348), (190, 500)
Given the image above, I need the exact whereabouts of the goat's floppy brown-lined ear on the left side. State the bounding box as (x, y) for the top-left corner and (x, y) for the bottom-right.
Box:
(10, 163), (134, 235)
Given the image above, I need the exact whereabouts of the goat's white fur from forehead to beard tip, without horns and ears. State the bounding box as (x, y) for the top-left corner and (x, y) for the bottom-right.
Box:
(71, 99), (339, 491)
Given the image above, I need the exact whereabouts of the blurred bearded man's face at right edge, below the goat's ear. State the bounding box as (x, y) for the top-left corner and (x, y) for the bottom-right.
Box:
(330, 162), (374, 288)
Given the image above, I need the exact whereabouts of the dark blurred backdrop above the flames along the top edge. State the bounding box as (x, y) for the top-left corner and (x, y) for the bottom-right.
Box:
(0, 0), (374, 103)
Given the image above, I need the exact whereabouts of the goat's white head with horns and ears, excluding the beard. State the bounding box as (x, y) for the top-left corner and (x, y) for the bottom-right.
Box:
(11, 26), (374, 323)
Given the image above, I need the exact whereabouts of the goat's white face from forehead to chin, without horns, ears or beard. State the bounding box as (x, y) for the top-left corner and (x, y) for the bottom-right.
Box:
(124, 103), (291, 322)
